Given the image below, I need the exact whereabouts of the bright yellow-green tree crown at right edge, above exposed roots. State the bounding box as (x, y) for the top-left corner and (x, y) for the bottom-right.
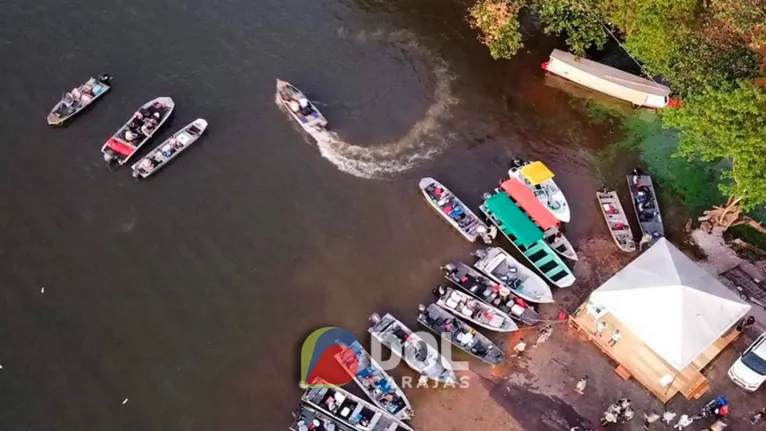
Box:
(663, 80), (766, 209)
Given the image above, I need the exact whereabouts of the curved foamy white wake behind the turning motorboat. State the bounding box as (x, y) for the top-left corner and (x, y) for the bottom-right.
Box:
(312, 31), (457, 179)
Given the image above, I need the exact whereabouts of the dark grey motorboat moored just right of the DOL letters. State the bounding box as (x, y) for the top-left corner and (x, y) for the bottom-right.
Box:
(418, 304), (505, 365)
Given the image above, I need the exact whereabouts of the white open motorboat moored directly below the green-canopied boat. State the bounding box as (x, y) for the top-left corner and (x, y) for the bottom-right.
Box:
(473, 247), (553, 304)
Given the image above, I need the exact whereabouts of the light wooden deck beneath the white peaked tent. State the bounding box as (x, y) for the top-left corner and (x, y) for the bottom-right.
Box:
(569, 305), (740, 403)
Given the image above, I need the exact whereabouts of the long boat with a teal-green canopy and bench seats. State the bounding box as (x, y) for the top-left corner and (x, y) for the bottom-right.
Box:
(477, 193), (575, 290)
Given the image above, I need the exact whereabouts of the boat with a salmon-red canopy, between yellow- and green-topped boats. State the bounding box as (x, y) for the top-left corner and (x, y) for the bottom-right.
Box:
(500, 178), (577, 260)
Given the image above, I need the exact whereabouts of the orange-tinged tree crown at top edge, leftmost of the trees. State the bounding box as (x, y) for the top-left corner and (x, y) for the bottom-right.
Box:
(468, 0), (524, 59)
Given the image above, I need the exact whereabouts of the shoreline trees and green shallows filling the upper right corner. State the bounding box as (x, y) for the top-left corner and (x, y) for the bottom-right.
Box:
(467, 0), (766, 248)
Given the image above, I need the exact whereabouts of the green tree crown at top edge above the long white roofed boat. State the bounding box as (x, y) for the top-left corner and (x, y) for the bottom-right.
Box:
(533, 0), (608, 56)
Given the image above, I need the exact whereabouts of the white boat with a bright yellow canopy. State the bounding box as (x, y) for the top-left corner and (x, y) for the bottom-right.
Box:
(508, 157), (572, 223)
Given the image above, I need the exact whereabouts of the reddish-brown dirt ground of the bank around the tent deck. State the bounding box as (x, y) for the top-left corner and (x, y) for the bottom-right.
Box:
(413, 239), (766, 431)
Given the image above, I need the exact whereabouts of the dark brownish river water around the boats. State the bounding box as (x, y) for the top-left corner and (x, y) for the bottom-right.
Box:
(0, 0), (656, 430)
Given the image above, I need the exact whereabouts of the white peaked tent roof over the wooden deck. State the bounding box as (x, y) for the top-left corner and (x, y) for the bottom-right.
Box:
(590, 238), (750, 370)
